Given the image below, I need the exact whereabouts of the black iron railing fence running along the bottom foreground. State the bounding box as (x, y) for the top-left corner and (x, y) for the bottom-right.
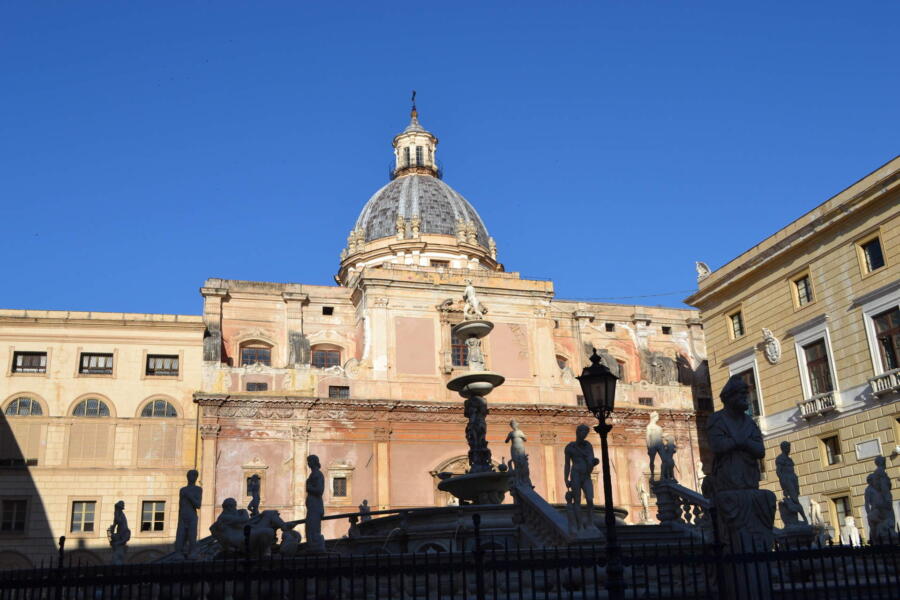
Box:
(0, 538), (900, 600)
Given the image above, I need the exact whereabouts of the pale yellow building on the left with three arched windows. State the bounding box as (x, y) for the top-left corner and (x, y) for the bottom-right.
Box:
(0, 310), (204, 569)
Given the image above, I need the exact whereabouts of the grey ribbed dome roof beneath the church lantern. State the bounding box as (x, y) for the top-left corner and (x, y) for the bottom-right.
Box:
(356, 175), (488, 248)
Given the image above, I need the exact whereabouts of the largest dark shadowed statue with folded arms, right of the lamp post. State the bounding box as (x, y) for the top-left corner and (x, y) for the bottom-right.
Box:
(707, 375), (775, 548)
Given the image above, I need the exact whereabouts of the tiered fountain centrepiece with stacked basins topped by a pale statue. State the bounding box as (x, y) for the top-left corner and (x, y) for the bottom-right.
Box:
(438, 281), (512, 504)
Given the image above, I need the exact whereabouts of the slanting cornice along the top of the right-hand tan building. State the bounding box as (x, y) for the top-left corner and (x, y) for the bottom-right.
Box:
(684, 155), (900, 306)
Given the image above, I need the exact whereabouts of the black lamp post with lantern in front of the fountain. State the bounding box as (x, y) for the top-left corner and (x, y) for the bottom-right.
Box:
(577, 348), (625, 600)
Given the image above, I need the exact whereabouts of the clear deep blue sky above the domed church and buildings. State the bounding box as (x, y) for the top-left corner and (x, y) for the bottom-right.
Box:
(0, 2), (900, 313)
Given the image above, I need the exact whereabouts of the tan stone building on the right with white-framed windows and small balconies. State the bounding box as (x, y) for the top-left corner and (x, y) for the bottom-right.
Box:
(686, 158), (900, 537)
